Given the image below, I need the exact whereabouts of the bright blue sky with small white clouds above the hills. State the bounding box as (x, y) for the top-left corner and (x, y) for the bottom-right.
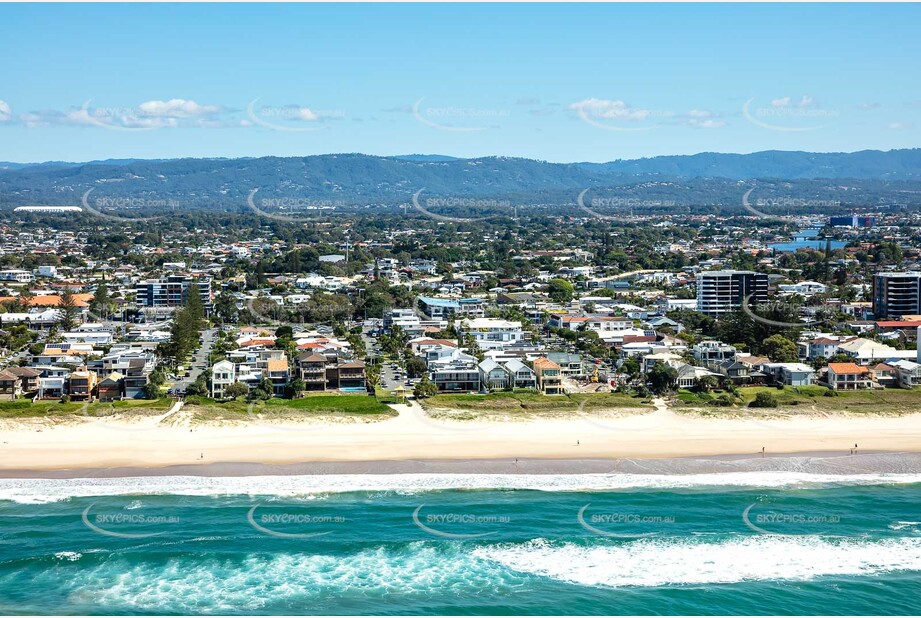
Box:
(0, 4), (921, 162)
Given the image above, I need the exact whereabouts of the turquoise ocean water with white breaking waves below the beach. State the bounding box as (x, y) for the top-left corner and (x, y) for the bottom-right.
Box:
(0, 472), (921, 615)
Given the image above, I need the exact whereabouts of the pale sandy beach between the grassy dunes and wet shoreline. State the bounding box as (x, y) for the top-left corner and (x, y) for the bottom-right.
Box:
(0, 401), (921, 471)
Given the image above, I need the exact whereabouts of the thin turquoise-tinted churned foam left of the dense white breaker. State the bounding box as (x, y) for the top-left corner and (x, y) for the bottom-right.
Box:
(54, 542), (521, 614)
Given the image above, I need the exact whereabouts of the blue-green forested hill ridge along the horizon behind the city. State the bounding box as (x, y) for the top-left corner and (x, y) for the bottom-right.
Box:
(0, 149), (921, 208)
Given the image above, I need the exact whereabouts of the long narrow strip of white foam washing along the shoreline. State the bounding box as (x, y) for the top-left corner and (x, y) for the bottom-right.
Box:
(0, 472), (921, 504)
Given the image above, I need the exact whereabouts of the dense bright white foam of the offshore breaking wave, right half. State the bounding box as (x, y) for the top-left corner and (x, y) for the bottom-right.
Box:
(473, 536), (921, 587)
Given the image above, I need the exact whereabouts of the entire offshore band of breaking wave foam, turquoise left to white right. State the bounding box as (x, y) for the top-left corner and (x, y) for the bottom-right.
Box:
(21, 536), (921, 614)
